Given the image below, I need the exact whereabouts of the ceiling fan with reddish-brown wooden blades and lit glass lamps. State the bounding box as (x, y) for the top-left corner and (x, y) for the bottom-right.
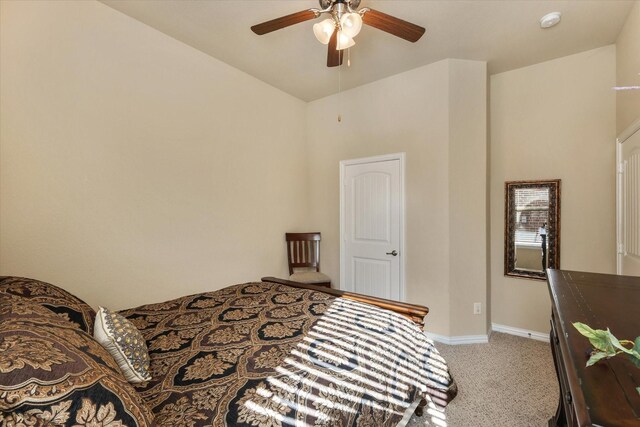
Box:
(251, 0), (425, 67)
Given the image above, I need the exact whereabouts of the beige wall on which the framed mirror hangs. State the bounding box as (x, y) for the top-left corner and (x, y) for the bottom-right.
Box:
(490, 46), (616, 332)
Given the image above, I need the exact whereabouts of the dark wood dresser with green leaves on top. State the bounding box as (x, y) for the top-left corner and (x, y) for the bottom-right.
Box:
(547, 269), (640, 427)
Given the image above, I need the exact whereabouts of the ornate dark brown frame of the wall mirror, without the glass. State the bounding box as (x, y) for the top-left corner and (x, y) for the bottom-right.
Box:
(504, 179), (560, 280)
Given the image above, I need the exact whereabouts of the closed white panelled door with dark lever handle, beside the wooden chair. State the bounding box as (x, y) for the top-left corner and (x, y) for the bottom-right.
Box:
(340, 154), (404, 300)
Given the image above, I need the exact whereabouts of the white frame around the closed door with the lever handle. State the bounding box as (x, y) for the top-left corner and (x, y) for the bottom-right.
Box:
(340, 152), (407, 301)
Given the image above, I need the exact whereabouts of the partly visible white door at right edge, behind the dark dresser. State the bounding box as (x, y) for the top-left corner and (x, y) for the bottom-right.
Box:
(618, 122), (640, 276)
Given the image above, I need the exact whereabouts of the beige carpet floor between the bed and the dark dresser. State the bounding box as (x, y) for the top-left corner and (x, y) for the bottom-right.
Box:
(408, 332), (558, 427)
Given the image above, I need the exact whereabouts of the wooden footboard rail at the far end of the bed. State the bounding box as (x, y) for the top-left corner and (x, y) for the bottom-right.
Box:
(262, 277), (429, 328)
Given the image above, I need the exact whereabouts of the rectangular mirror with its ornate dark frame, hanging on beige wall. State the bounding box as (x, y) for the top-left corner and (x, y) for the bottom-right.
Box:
(504, 179), (560, 280)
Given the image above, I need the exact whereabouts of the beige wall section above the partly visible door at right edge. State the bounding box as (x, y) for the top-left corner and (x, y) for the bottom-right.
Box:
(616, 1), (640, 134)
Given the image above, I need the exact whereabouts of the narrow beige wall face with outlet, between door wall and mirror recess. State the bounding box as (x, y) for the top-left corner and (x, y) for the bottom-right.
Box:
(448, 60), (489, 336)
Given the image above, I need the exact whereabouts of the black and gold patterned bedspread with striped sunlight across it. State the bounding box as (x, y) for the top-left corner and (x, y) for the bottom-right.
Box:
(121, 282), (455, 427)
